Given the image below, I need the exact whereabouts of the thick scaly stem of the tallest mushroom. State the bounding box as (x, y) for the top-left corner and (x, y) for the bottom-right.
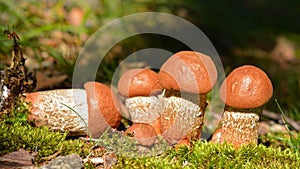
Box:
(161, 90), (207, 142)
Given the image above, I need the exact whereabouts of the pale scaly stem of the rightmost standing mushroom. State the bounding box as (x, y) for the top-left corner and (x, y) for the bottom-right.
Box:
(222, 111), (259, 147)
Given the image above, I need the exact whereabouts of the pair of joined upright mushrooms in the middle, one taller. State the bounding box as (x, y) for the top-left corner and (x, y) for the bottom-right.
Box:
(118, 51), (217, 144)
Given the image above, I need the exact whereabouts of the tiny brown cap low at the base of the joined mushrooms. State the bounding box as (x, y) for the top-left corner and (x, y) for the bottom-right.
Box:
(125, 123), (157, 146)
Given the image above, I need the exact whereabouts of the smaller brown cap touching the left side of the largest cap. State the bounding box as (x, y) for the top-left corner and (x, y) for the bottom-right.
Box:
(118, 68), (162, 97)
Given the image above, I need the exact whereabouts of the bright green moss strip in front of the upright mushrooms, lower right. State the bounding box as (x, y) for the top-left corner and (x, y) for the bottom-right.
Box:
(115, 142), (300, 168)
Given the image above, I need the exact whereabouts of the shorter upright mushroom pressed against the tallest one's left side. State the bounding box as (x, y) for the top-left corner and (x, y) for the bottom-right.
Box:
(118, 68), (162, 134)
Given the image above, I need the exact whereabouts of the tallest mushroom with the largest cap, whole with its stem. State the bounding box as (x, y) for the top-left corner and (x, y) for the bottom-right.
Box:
(158, 51), (217, 144)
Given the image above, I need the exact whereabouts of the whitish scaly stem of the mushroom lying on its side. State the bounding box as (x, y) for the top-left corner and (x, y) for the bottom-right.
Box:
(25, 89), (88, 135)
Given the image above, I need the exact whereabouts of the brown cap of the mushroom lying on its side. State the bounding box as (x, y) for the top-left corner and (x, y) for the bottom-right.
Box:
(84, 82), (122, 138)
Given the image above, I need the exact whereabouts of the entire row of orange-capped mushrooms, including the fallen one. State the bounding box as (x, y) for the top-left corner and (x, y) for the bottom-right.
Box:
(26, 51), (273, 147)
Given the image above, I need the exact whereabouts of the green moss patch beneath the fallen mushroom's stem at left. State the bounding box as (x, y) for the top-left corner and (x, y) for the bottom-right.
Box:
(0, 103), (91, 162)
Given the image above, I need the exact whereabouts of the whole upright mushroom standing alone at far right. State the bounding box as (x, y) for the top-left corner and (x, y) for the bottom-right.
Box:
(220, 65), (273, 148)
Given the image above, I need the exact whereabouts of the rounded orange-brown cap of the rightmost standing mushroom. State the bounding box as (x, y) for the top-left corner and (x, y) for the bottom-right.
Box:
(220, 65), (273, 109)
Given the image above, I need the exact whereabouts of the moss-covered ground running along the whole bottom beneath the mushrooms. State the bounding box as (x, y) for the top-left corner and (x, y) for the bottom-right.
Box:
(0, 103), (300, 168)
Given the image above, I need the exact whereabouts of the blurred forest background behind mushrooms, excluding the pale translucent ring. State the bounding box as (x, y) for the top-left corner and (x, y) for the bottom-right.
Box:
(0, 0), (300, 121)
